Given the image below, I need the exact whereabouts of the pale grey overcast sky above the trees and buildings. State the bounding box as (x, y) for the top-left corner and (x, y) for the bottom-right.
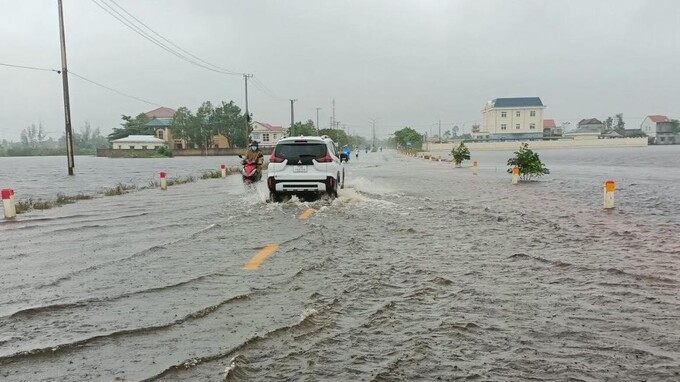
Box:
(0, 0), (680, 141)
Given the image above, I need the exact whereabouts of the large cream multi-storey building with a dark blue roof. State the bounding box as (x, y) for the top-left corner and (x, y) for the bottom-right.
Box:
(477, 97), (545, 140)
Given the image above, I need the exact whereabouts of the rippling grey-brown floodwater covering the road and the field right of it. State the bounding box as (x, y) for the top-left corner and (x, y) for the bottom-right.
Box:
(0, 147), (680, 381)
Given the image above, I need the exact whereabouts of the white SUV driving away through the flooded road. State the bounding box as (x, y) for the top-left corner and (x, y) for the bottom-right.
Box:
(267, 135), (345, 202)
